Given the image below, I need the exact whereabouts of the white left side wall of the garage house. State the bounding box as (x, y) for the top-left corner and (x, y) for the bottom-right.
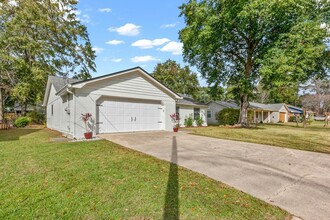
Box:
(47, 86), (73, 135)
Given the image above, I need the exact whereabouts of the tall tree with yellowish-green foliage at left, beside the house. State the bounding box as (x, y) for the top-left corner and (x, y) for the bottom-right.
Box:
(0, 0), (95, 118)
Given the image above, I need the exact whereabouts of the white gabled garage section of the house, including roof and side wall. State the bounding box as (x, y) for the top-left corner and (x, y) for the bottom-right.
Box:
(43, 67), (182, 138)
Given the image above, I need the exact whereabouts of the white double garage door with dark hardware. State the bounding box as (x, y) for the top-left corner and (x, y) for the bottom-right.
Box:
(97, 100), (162, 133)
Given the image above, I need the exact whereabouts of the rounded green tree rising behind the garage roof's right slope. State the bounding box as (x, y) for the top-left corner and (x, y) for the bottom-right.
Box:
(152, 59), (199, 97)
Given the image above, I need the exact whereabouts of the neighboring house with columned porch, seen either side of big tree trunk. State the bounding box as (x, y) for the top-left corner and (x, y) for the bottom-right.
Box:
(207, 101), (289, 124)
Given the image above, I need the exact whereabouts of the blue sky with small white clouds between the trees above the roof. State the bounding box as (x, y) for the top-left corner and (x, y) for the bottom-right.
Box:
(77, 0), (195, 77)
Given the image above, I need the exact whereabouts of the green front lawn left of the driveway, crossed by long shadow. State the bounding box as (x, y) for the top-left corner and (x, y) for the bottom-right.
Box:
(0, 128), (291, 219)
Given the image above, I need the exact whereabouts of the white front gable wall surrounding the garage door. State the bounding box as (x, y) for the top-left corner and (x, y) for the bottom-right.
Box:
(74, 72), (175, 139)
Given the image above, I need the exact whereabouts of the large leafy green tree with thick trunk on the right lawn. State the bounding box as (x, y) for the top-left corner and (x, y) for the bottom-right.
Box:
(179, 0), (330, 126)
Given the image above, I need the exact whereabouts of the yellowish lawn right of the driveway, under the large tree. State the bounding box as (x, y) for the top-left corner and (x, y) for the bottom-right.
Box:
(189, 122), (330, 154)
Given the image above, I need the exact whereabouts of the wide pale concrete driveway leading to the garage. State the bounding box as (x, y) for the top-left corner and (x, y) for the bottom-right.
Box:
(99, 132), (330, 220)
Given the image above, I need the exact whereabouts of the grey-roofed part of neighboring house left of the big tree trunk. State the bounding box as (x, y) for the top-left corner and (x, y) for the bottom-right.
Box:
(207, 101), (239, 125)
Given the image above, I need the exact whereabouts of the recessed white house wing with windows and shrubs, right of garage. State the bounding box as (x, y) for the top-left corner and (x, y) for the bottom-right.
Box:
(176, 95), (208, 127)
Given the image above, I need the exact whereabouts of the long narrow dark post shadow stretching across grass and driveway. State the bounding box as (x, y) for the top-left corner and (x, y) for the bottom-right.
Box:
(163, 137), (180, 219)
